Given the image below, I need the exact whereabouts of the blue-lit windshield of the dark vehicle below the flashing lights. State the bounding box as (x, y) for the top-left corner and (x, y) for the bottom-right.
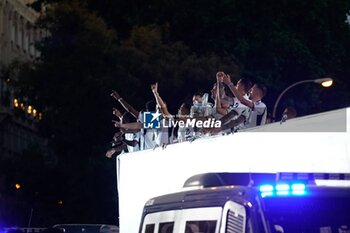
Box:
(264, 195), (350, 233)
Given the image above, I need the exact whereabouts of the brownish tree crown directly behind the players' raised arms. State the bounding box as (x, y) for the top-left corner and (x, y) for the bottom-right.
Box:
(113, 25), (238, 112)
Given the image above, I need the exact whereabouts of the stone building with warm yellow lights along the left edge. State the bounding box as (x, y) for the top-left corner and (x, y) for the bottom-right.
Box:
(0, 0), (51, 228)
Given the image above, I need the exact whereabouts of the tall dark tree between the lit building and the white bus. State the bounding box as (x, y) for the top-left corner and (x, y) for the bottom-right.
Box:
(12, 1), (117, 224)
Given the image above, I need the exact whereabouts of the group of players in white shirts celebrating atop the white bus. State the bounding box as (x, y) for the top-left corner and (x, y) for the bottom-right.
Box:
(106, 71), (296, 158)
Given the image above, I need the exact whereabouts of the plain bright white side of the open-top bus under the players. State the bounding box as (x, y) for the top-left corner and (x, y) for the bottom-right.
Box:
(117, 108), (350, 233)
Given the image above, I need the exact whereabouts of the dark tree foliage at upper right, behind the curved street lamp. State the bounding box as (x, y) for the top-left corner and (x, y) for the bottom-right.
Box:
(89, 0), (350, 115)
